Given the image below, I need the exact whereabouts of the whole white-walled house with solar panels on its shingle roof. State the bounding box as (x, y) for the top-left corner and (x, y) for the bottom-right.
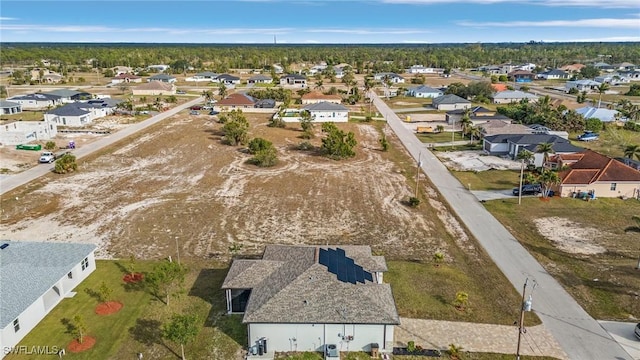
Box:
(222, 245), (400, 352)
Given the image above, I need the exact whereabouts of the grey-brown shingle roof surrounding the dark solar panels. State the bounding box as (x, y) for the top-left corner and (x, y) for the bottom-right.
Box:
(222, 245), (400, 324)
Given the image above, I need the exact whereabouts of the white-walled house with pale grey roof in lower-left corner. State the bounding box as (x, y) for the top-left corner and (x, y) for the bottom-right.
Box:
(0, 241), (96, 357)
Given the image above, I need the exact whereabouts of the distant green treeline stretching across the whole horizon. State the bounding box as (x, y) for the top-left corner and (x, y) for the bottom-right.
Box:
(0, 42), (640, 72)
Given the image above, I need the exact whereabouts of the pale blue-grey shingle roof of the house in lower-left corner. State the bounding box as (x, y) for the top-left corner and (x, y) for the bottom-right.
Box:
(0, 241), (96, 329)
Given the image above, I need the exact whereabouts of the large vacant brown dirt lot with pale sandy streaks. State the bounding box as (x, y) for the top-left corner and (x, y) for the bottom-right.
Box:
(0, 114), (462, 258)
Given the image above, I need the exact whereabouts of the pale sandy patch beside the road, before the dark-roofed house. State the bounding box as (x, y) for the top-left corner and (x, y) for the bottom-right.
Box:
(435, 150), (520, 171)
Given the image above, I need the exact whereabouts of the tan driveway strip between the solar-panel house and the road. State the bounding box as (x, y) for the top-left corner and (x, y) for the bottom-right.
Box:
(394, 318), (568, 360)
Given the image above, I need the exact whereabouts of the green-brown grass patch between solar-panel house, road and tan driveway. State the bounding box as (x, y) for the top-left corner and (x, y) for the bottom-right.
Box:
(385, 259), (540, 325)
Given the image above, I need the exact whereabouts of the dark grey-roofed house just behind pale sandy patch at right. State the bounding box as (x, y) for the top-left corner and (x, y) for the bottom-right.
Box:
(482, 134), (584, 167)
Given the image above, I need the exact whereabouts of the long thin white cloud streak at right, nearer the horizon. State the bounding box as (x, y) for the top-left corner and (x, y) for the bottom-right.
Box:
(456, 19), (638, 29)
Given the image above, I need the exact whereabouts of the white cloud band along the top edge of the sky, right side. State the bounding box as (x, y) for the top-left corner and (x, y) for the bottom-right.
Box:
(381, 0), (638, 8)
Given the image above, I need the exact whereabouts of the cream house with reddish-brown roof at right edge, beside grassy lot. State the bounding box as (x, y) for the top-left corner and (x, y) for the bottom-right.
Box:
(555, 150), (640, 198)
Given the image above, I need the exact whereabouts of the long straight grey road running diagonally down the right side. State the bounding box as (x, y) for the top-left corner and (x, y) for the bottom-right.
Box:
(370, 94), (631, 360)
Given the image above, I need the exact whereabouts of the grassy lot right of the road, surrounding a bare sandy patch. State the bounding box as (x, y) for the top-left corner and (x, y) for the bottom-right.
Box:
(485, 198), (640, 320)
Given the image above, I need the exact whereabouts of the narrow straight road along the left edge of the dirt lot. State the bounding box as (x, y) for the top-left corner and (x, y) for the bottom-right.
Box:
(0, 97), (204, 195)
